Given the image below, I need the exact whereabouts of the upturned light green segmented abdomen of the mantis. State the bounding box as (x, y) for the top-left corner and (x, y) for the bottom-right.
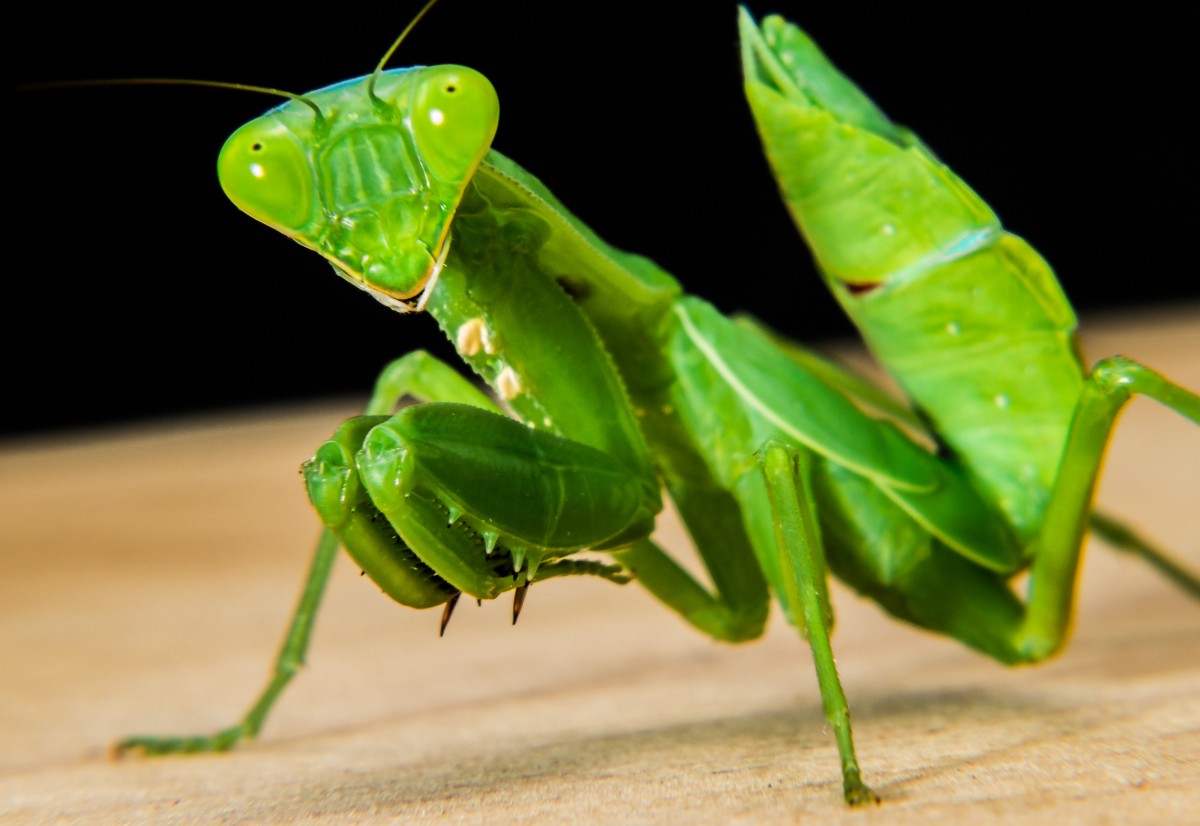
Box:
(746, 18), (1084, 539)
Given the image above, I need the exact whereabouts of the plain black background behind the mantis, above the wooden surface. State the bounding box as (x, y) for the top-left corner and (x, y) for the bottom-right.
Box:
(7, 0), (1200, 436)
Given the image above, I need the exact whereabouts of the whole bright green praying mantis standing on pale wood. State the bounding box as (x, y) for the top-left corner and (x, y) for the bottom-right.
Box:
(108, 10), (1200, 804)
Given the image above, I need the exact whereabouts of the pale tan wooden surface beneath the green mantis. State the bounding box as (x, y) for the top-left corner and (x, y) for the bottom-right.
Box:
(0, 306), (1200, 824)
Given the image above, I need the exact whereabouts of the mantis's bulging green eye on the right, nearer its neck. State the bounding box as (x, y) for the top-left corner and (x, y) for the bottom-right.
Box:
(410, 66), (500, 182)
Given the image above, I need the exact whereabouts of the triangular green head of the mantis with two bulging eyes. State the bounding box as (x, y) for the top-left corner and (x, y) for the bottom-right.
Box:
(217, 66), (499, 310)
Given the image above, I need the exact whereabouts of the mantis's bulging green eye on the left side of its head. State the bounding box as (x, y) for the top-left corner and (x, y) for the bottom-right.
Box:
(217, 120), (313, 233)
